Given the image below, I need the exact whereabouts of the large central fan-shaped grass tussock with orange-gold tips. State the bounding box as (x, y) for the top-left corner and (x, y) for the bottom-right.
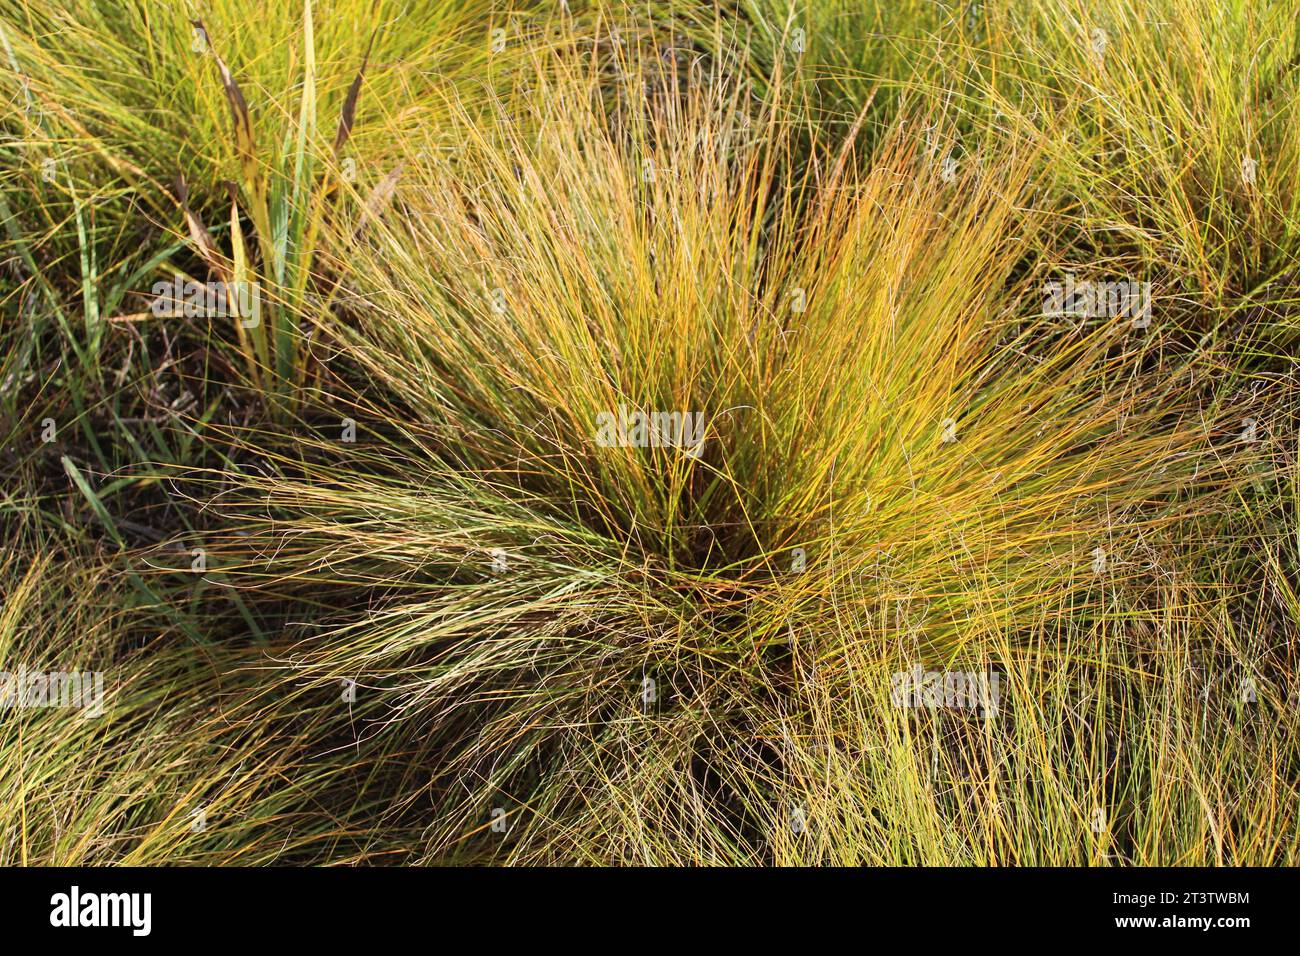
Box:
(167, 39), (1291, 862)
